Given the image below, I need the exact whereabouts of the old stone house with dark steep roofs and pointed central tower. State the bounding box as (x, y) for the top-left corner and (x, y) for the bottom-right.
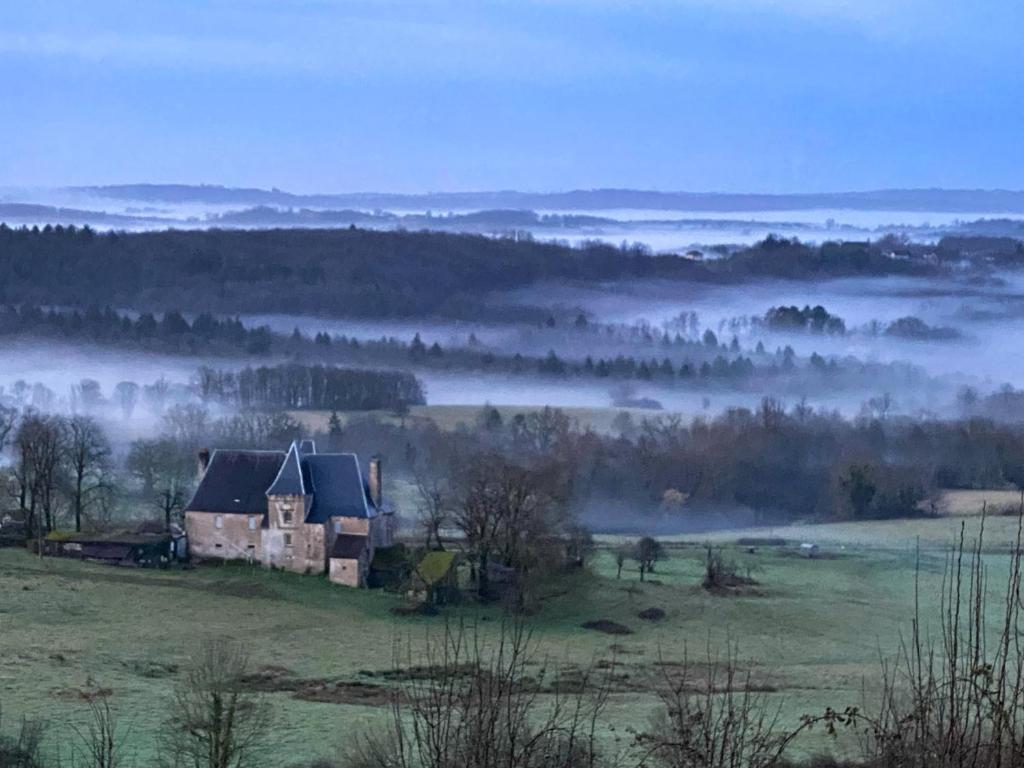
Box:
(185, 440), (394, 587)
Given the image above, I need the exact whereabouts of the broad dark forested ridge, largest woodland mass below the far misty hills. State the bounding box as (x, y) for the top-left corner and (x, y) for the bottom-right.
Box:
(0, 224), (969, 318)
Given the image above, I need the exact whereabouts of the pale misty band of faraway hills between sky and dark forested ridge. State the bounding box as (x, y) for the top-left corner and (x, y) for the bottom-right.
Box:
(6, 185), (1024, 252)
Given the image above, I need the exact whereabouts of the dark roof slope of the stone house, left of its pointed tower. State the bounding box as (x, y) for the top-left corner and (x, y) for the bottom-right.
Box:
(185, 450), (285, 515)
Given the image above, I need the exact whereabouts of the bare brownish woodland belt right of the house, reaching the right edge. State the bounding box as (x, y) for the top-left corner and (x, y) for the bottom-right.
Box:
(331, 399), (1024, 536)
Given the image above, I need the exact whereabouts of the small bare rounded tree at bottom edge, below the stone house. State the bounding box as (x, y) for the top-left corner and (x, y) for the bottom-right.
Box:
(166, 640), (270, 768)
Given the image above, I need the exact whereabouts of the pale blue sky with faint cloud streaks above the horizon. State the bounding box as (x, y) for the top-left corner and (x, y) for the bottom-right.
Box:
(0, 0), (1024, 193)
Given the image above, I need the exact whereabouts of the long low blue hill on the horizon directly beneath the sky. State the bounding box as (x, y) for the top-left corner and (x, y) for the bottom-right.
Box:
(71, 184), (1024, 213)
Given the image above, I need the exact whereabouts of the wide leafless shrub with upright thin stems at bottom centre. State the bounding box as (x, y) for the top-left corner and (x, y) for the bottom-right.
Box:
(343, 624), (612, 768)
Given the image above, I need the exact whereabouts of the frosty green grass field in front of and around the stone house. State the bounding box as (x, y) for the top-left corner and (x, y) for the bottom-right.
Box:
(0, 518), (1016, 765)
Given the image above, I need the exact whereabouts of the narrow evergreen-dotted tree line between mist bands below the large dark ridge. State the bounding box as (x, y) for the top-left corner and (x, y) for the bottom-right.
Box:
(0, 306), (933, 397)
